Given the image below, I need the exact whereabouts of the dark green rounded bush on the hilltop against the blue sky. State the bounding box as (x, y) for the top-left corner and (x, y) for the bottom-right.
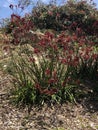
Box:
(31, 0), (98, 35)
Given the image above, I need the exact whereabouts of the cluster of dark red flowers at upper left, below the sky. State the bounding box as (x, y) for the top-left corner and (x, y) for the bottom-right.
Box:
(9, 14), (33, 45)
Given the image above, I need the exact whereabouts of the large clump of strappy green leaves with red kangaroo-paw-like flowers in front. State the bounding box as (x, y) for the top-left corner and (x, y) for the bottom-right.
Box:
(6, 32), (98, 105)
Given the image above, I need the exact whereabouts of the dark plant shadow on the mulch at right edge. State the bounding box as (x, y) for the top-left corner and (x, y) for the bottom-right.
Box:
(77, 81), (98, 113)
